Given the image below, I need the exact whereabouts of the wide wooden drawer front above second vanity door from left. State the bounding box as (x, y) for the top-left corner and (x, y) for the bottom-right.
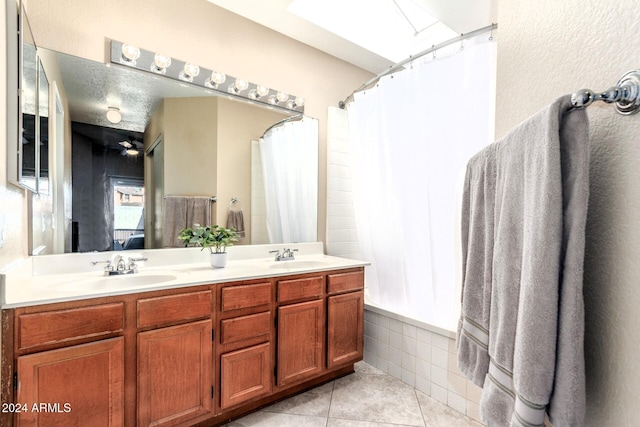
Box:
(138, 291), (211, 328)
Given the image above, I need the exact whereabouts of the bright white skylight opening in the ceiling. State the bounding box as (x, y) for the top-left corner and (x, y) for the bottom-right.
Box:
(287, 0), (458, 62)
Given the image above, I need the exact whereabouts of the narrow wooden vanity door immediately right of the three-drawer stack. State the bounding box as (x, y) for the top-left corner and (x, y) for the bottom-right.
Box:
(277, 300), (324, 386)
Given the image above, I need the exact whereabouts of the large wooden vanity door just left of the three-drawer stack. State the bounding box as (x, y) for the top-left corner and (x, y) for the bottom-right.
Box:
(138, 320), (213, 426)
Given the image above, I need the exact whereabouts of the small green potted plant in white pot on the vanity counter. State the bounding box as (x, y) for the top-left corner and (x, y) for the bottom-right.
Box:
(178, 224), (238, 267)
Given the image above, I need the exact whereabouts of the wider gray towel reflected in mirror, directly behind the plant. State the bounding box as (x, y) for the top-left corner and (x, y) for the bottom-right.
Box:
(163, 196), (211, 248)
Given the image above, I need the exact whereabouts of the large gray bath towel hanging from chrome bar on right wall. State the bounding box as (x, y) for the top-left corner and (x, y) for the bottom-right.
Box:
(458, 96), (589, 427)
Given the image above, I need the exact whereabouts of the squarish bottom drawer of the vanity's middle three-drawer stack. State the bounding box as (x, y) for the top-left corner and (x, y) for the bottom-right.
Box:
(220, 343), (272, 410)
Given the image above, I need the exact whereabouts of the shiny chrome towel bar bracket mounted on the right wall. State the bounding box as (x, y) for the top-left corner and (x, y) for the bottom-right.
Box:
(571, 70), (640, 115)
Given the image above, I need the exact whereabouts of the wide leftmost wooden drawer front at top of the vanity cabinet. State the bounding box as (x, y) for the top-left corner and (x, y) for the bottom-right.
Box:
(18, 302), (124, 350)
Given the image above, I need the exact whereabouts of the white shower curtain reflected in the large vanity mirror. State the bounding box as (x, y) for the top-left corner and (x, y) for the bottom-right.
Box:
(259, 117), (318, 243)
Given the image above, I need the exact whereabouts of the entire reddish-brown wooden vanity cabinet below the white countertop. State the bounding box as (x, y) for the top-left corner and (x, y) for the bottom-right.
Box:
(0, 267), (364, 427)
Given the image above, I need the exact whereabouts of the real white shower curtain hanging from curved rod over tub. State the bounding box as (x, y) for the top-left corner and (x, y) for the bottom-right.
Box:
(348, 35), (495, 330)
